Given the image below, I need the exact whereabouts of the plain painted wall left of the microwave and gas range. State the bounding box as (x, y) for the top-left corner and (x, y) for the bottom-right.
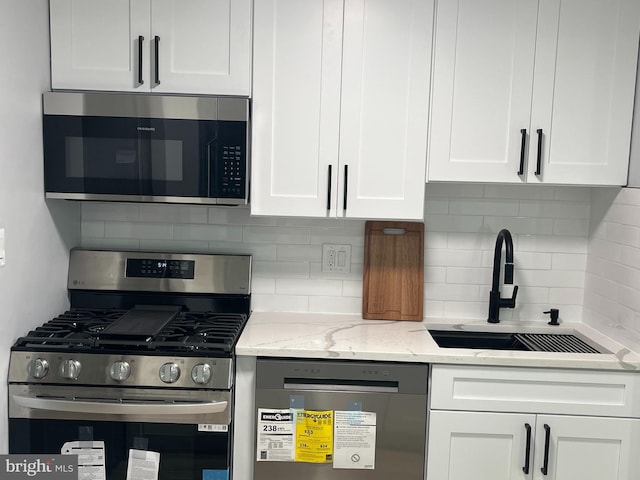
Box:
(0, 0), (79, 453)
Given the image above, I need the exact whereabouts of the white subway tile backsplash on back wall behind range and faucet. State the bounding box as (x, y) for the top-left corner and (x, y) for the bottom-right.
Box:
(81, 183), (590, 320)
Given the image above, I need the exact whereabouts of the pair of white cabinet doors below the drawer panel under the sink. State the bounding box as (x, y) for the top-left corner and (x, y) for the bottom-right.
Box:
(427, 410), (640, 480)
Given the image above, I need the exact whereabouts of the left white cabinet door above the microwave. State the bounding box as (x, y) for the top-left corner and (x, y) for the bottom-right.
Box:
(49, 0), (150, 91)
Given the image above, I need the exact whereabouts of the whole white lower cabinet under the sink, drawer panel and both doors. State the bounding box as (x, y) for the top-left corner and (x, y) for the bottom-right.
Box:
(426, 365), (640, 480)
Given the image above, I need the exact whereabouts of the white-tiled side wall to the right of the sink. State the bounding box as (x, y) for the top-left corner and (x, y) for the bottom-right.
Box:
(584, 188), (640, 351)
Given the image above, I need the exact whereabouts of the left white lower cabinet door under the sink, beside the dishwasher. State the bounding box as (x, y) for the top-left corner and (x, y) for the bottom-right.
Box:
(427, 411), (536, 480)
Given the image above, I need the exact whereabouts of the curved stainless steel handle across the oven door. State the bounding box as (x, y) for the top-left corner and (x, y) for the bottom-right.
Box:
(13, 395), (229, 415)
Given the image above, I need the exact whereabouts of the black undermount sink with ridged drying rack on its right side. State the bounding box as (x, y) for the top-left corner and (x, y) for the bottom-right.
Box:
(429, 330), (608, 353)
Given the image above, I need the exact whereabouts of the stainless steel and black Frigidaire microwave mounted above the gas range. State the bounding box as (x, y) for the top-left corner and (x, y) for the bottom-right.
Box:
(43, 92), (250, 205)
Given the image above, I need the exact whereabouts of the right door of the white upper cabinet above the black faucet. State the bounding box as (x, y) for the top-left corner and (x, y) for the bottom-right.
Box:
(528, 0), (640, 185)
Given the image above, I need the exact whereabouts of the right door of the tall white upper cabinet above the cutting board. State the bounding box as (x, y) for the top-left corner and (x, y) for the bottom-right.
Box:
(338, 0), (433, 219)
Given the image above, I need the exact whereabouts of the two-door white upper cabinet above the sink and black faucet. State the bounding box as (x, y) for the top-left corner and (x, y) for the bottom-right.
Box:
(428, 0), (640, 185)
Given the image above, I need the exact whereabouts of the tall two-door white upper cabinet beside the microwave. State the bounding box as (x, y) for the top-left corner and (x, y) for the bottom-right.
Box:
(251, 0), (433, 219)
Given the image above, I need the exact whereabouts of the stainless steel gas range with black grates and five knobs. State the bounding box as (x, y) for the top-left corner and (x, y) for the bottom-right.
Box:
(9, 249), (251, 480)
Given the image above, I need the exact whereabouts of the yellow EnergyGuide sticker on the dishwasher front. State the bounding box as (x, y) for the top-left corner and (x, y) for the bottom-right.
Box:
(295, 410), (333, 463)
